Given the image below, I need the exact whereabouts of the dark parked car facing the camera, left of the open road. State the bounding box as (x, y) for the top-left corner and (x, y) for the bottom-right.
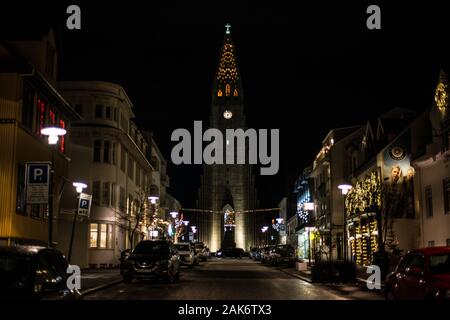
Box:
(121, 240), (180, 283)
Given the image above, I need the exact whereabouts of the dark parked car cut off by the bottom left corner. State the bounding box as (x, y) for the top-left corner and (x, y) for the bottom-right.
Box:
(0, 246), (81, 300)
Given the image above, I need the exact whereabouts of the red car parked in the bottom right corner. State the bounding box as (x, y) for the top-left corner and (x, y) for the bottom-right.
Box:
(385, 247), (450, 300)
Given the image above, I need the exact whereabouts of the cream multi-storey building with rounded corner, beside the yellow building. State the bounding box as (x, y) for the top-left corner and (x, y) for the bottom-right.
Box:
(59, 81), (159, 267)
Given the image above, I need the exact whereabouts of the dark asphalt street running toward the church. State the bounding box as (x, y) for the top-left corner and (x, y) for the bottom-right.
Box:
(84, 258), (382, 300)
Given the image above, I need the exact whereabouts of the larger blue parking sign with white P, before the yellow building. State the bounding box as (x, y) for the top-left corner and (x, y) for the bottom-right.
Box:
(25, 162), (50, 204)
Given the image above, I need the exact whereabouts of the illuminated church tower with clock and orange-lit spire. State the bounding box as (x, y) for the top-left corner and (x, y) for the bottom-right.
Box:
(195, 24), (256, 251)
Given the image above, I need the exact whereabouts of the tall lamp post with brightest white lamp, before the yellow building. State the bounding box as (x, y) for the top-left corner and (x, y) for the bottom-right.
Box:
(41, 127), (67, 247)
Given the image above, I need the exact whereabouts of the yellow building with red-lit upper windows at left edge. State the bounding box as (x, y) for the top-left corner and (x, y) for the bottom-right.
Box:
(0, 30), (79, 245)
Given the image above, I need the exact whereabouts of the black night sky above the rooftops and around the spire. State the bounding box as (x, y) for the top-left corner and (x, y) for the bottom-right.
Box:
(0, 0), (450, 207)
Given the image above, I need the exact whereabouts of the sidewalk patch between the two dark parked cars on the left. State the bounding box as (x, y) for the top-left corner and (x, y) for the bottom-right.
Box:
(80, 269), (122, 295)
